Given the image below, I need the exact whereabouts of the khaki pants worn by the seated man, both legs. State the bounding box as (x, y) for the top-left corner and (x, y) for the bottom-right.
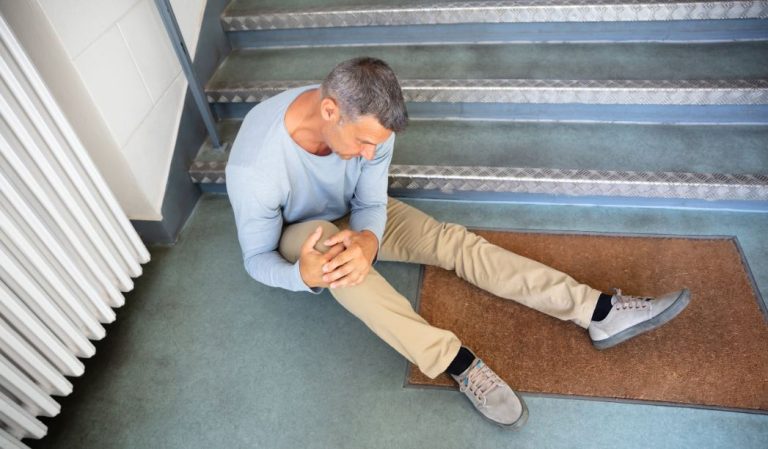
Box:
(279, 198), (600, 379)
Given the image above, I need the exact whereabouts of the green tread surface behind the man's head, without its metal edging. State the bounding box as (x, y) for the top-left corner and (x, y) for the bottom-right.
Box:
(208, 42), (768, 85)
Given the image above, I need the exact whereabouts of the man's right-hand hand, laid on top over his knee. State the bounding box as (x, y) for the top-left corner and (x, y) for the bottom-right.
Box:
(322, 229), (379, 288)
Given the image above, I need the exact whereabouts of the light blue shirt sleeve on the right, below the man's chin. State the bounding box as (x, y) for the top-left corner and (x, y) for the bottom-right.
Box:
(349, 133), (395, 249)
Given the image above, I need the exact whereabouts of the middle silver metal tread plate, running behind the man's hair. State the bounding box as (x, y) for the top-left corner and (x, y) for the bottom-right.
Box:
(206, 79), (768, 105)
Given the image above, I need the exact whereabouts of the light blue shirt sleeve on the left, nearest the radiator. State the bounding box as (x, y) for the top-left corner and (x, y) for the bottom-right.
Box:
(226, 165), (322, 293)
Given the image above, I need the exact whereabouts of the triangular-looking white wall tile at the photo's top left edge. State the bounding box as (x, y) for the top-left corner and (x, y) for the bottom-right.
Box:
(37, 0), (139, 59)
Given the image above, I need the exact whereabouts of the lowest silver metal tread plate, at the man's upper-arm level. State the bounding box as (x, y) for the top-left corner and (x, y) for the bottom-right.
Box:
(189, 161), (768, 201)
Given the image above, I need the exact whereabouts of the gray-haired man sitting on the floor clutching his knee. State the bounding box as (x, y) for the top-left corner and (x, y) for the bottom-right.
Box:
(227, 58), (690, 429)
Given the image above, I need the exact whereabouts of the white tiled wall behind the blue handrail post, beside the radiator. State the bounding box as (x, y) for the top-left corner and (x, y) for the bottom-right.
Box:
(32, 0), (206, 220)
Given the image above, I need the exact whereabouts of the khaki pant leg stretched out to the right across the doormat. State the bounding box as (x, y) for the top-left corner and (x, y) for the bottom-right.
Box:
(379, 198), (601, 328)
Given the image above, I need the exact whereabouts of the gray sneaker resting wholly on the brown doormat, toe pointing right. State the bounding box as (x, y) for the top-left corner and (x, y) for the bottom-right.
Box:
(589, 288), (691, 349)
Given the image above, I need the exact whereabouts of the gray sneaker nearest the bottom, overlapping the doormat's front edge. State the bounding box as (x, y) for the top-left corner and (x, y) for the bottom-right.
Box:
(451, 357), (528, 430)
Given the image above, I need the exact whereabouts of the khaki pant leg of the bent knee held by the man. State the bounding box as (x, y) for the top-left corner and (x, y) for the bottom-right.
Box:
(279, 221), (461, 379)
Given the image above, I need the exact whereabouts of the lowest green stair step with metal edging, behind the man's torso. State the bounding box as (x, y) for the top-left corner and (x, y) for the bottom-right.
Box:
(190, 121), (768, 211)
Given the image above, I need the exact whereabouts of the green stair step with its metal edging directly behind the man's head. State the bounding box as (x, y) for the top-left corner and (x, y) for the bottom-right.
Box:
(206, 42), (768, 116)
